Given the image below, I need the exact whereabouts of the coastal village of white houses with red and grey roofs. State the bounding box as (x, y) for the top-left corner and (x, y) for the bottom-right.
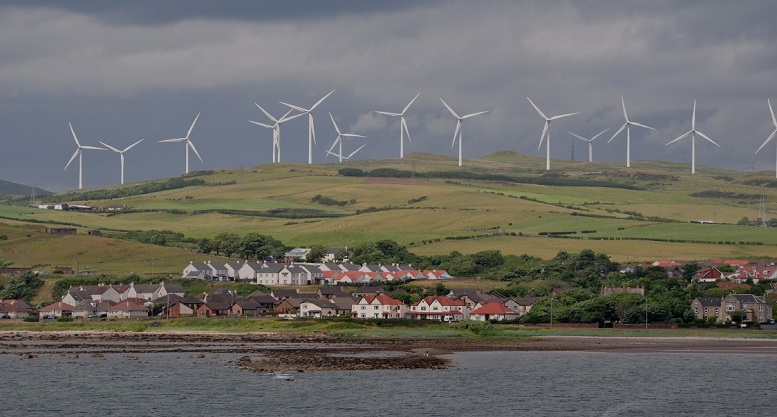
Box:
(0, 248), (777, 325)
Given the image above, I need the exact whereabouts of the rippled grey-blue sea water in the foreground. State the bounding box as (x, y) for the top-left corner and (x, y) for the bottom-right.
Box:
(0, 352), (777, 417)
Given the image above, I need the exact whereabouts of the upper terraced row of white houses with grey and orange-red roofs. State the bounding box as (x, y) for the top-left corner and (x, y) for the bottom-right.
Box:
(181, 260), (451, 286)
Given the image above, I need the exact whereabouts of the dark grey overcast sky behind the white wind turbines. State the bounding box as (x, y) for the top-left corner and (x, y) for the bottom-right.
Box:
(0, 0), (777, 191)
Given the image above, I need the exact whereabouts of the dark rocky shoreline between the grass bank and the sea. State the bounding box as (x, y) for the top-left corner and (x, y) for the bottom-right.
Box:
(0, 331), (777, 372)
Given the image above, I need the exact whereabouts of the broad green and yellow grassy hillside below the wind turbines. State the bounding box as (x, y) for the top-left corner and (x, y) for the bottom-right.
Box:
(0, 151), (777, 272)
